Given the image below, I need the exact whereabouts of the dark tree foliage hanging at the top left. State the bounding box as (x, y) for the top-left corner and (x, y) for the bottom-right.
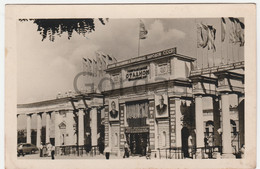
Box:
(19, 18), (108, 42)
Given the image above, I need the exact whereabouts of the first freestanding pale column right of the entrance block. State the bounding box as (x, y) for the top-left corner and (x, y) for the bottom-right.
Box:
(195, 95), (204, 147)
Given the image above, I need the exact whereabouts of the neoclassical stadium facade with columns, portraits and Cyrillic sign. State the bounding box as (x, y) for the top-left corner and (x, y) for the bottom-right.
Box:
(18, 48), (245, 158)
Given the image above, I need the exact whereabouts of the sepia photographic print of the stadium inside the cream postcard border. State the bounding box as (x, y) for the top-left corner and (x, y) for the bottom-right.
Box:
(6, 5), (254, 169)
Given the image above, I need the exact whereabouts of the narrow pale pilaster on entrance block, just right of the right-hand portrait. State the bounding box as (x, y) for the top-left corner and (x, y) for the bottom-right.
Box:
(175, 98), (182, 147)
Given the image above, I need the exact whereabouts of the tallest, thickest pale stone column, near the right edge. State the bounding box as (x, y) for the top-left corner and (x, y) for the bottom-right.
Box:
(221, 93), (234, 158)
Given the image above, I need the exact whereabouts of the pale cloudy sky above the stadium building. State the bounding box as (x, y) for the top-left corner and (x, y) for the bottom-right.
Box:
(17, 18), (242, 104)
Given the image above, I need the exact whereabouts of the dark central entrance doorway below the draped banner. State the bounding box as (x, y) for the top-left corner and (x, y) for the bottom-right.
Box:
(129, 133), (149, 156)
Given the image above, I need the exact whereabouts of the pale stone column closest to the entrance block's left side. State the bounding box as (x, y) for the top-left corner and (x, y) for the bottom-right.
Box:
(90, 107), (97, 146)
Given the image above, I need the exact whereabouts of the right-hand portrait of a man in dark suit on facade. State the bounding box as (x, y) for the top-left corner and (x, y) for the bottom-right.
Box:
(155, 94), (169, 118)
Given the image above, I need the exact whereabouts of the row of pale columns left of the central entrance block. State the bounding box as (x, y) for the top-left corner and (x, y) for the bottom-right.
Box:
(22, 107), (98, 147)
